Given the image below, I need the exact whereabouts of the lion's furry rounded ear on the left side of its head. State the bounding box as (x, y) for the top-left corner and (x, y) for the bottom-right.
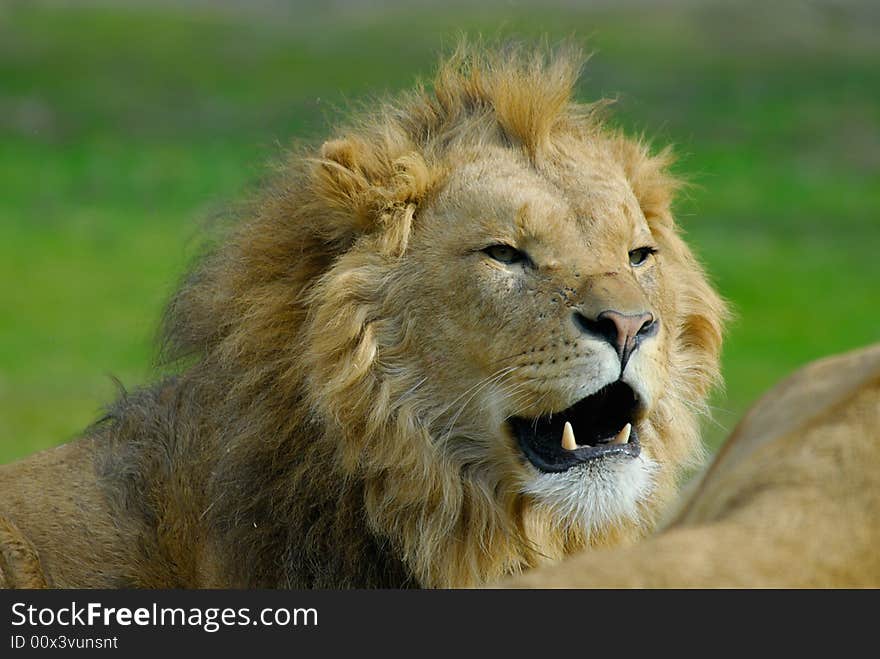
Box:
(313, 136), (436, 254)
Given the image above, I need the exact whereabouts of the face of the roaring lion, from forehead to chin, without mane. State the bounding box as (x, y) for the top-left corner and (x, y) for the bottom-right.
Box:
(382, 149), (674, 528)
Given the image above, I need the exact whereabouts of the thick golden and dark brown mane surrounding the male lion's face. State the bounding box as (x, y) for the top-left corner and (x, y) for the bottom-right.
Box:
(1, 46), (725, 588)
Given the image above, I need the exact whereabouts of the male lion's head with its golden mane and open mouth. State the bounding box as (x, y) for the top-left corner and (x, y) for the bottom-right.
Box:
(162, 42), (724, 586)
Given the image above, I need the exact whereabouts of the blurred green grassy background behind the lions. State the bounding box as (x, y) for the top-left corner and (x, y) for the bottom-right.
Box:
(0, 0), (880, 462)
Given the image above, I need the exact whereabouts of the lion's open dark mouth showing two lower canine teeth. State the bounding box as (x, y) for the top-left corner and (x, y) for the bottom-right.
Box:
(507, 380), (641, 472)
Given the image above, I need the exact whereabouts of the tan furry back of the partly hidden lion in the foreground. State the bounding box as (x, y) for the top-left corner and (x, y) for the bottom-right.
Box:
(504, 344), (880, 588)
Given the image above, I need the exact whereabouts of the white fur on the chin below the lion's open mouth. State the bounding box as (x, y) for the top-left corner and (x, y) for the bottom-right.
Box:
(523, 454), (657, 536)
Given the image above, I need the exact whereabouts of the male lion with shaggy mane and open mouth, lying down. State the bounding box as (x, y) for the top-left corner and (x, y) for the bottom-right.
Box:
(0, 45), (726, 589)
